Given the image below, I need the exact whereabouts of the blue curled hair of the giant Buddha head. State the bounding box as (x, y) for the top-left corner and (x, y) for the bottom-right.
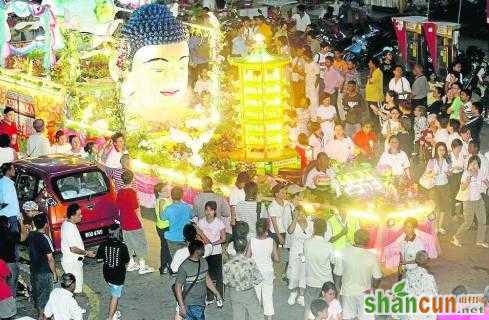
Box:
(122, 4), (188, 61)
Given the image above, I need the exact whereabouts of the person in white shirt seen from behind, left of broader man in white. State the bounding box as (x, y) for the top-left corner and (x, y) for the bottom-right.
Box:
(304, 219), (335, 320)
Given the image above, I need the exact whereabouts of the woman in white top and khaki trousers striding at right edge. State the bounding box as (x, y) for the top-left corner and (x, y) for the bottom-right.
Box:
(451, 156), (489, 248)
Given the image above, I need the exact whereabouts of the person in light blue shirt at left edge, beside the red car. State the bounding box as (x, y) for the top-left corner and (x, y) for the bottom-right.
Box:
(0, 162), (20, 232)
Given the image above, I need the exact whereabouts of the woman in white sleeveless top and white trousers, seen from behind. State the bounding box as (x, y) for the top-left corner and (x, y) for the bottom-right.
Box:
(246, 219), (279, 320)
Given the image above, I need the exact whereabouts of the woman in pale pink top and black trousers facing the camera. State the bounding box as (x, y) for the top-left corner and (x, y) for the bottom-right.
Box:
(197, 201), (226, 302)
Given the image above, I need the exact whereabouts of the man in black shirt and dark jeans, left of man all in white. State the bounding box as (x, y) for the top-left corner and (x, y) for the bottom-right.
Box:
(26, 214), (58, 315)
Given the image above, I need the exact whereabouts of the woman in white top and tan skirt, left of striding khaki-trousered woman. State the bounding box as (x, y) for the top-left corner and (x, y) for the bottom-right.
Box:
(425, 142), (451, 234)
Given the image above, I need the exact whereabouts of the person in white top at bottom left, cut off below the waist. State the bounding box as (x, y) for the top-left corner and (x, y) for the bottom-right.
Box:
(44, 273), (85, 320)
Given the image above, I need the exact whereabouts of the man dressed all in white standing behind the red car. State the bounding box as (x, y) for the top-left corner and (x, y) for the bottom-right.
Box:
(61, 203), (95, 293)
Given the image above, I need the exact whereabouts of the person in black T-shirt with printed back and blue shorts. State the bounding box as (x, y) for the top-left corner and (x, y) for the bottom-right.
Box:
(97, 224), (129, 320)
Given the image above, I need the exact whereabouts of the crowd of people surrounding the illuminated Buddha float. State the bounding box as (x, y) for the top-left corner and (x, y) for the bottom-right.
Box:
(0, 2), (489, 320)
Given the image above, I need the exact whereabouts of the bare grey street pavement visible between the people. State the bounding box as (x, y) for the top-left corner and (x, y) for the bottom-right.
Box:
(13, 123), (489, 320)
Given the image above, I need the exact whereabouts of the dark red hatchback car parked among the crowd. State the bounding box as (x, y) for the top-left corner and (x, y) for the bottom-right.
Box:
(14, 155), (118, 250)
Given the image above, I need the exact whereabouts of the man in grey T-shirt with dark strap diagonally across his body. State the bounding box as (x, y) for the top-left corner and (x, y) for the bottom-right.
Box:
(174, 240), (222, 320)
